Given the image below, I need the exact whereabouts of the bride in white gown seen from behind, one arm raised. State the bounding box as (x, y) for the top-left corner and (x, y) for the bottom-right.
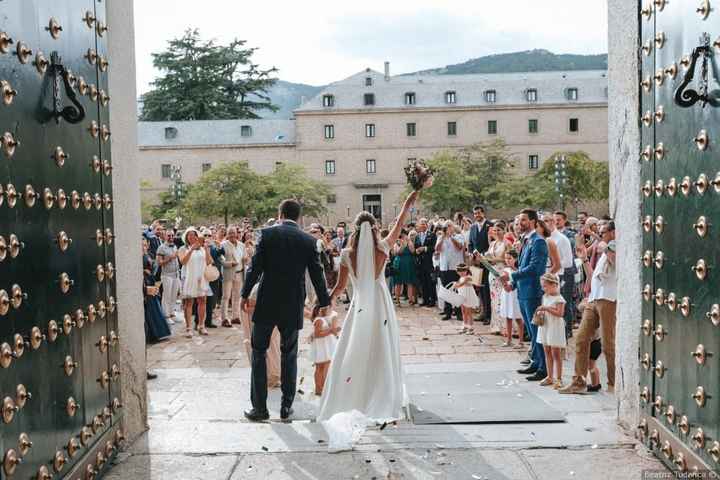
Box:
(317, 191), (418, 423)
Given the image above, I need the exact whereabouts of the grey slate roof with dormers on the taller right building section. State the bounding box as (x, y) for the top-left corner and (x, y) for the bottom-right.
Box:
(295, 69), (608, 113)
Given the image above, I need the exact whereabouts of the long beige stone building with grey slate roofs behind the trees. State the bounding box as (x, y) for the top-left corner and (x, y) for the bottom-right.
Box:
(139, 64), (608, 223)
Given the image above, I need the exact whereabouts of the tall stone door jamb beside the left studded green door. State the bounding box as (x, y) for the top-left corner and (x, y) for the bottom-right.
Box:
(105, 0), (147, 444)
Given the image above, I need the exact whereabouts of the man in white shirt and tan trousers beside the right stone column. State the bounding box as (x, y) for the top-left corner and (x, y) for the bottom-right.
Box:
(559, 222), (617, 393)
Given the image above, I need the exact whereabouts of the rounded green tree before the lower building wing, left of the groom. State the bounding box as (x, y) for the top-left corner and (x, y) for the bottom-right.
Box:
(181, 162), (266, 222)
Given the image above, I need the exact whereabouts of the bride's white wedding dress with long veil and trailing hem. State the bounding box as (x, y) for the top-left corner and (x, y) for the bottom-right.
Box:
(317, 222), (407, 432)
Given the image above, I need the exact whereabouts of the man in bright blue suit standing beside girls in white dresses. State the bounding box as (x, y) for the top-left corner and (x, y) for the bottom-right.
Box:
(500, 208), (548, 382)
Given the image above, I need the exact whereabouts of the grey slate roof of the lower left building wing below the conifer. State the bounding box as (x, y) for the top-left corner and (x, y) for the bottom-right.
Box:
(138, 120), (295, 147)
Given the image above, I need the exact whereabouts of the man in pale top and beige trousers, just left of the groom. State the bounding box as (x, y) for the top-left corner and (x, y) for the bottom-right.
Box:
(220, 227), (245, 328)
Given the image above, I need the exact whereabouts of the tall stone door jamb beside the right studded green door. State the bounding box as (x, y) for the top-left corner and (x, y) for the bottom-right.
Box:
(608, 0), (642, 427)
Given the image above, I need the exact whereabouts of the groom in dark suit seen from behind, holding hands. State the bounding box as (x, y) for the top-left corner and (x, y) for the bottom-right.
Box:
(240, 200), (330, 422)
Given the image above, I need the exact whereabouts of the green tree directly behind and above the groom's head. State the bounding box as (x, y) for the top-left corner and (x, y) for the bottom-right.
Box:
(254, 164), (330, 221)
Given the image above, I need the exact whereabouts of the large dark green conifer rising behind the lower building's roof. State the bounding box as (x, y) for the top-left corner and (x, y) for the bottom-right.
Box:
(140, 30), (277, 121)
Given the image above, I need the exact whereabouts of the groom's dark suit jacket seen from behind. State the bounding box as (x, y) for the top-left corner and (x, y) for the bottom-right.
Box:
(242, 222), (330, 330)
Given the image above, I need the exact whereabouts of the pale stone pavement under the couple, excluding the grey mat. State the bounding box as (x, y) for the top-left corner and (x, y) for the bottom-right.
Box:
(106, 307), (663, 480)
